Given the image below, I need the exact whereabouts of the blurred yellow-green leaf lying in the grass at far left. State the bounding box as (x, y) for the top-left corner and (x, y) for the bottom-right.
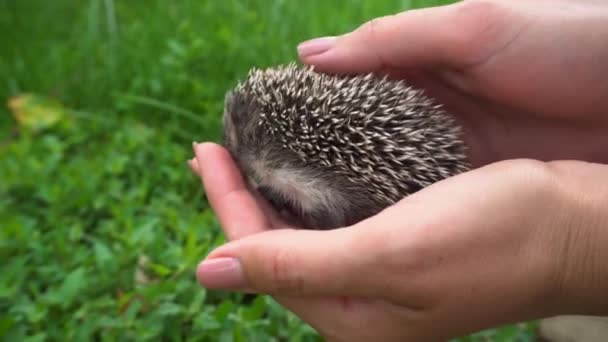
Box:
(8, 94), (66, 131)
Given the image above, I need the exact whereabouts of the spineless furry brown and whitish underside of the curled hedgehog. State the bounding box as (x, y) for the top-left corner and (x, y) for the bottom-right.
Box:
(223, 92), (348, 229)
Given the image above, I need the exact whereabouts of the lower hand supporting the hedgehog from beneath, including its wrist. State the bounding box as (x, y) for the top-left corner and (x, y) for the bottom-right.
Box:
(190, 144), (608, 341)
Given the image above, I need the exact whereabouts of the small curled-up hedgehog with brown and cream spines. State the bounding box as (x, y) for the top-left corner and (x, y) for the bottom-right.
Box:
(223, 63), (469, 229)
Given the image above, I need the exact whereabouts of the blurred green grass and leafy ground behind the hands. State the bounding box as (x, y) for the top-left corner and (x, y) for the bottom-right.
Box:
(0, 0), (533, 341)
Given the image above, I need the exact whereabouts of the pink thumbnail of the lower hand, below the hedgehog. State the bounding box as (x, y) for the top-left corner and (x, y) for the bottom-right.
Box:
(196, 258), (246, 289)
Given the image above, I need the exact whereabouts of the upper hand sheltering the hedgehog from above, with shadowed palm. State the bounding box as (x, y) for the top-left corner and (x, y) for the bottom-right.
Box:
(299, 0), (608, 166)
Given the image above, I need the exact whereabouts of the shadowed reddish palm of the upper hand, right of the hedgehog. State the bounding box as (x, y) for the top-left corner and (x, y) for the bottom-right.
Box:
(410, 75), (608, 166)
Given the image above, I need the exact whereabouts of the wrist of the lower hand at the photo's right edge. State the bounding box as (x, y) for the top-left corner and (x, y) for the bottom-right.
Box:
(545, 161), (608, 315)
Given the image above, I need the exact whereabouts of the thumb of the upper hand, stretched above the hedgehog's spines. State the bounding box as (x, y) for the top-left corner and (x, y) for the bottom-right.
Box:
(298, 2), (476, 73)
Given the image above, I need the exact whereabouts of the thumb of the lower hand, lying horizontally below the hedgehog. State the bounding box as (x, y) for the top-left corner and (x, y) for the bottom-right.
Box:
(197, 227), (386, 296)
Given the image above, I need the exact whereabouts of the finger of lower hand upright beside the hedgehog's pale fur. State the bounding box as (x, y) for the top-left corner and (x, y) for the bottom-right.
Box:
(191, 143), (271, 240)
